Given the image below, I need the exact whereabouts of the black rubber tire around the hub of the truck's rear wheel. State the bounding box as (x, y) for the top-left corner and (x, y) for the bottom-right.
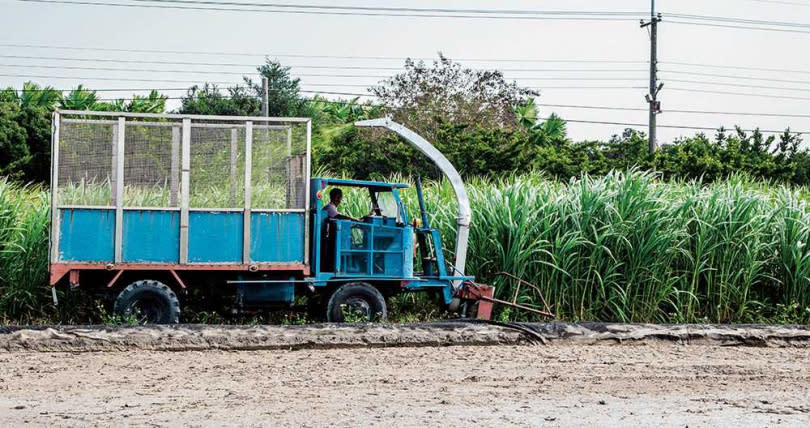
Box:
(113, 279), (180, 324)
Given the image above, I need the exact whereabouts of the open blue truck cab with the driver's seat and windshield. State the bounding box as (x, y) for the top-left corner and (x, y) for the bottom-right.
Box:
(310, 178), (464, 320)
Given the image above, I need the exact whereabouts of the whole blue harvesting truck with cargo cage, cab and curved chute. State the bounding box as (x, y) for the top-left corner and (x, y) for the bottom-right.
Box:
(50, 110), (495, 323)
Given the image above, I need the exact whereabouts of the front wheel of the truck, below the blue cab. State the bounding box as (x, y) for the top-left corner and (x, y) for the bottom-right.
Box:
(326, 282), (388, 322)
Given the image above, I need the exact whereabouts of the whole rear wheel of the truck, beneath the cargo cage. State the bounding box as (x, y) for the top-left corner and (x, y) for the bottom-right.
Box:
(114, 280), (180, 324)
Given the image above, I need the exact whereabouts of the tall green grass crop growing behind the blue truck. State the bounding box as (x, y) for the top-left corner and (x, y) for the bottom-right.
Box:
(0, 172), (810, 323)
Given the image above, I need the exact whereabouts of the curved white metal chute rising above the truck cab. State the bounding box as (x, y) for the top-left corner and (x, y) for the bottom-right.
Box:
(355, 118), (472, 284)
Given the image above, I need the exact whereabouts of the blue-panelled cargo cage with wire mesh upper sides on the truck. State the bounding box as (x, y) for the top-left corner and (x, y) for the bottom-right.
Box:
(50, 110), (311, 270)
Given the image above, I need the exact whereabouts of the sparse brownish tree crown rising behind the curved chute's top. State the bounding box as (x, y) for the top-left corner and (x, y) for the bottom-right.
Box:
(370, 53), (538, 140)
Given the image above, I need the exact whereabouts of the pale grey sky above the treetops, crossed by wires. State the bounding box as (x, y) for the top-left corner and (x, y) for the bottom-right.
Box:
(0, 0), (810, 143)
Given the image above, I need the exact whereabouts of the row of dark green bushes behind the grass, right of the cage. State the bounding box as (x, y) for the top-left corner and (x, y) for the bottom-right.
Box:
(313, 123), (810, 186)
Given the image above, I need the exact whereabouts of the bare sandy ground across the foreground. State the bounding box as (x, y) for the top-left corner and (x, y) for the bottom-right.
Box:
(0, 342), (810, 427)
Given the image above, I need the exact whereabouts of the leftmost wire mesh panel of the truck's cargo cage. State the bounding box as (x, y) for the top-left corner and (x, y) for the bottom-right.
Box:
(56, 118), (118, 206)
